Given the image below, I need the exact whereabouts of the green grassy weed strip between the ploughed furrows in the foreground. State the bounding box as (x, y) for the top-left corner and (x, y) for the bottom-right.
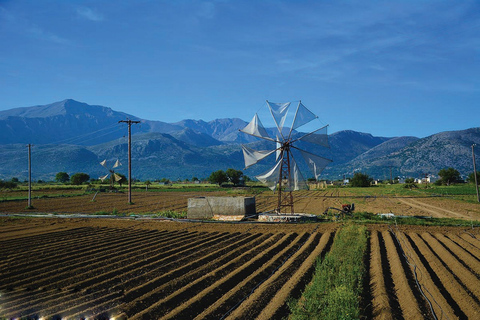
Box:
(289, 224), (368, 320)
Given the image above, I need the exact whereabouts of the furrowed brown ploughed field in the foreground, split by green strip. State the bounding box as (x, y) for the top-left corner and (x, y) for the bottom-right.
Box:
(0, 218), (480, 319)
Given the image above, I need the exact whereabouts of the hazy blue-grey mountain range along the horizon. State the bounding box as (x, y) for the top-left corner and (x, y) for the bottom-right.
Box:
(0, 99), (480, 180)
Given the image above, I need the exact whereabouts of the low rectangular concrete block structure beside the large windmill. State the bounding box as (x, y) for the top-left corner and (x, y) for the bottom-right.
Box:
(187, 197), (256, 221)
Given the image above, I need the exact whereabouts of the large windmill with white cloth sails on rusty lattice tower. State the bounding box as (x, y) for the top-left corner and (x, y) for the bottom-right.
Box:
(240, 101), (332, 214)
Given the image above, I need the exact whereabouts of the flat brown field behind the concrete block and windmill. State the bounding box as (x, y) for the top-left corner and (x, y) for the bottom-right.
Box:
(0, 188), (480, 220)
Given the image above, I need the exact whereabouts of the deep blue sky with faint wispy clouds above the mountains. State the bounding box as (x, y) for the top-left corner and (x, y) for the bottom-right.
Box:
(0, 0), (480, 137)
